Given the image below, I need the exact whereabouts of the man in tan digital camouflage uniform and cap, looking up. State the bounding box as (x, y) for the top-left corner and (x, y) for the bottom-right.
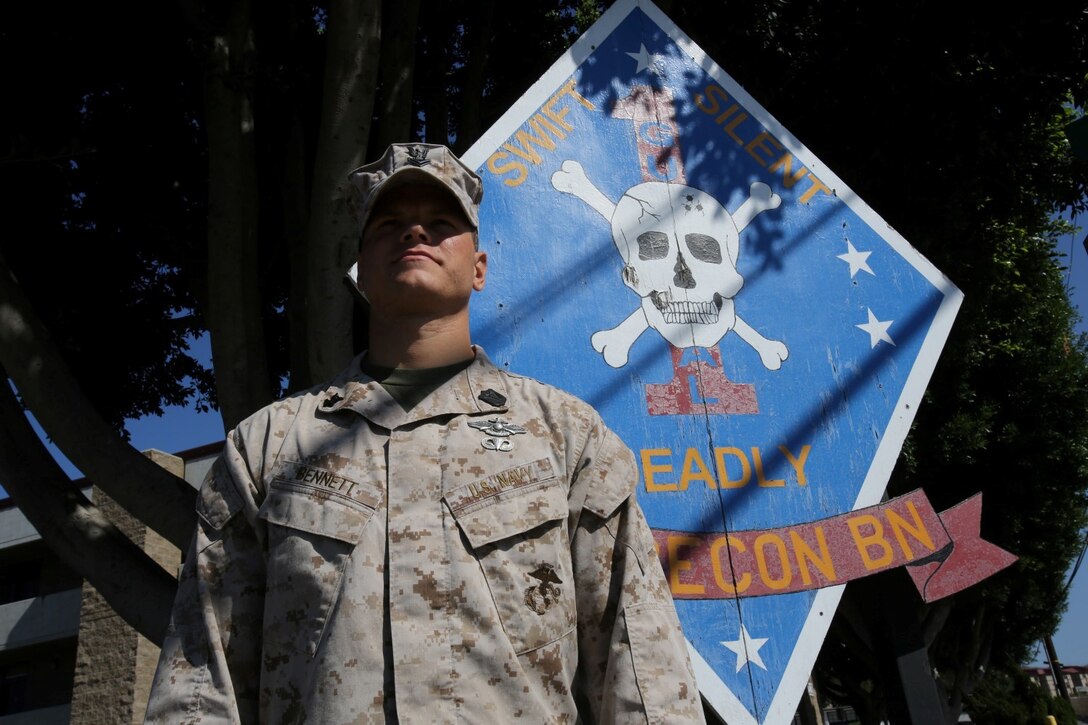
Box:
(147, 144), (703, 725)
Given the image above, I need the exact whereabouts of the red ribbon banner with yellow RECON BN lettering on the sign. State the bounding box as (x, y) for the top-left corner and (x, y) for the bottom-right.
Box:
(654, 489), (1016, 602)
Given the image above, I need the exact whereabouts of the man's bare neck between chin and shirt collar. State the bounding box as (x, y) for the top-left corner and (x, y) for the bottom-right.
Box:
(367, 314), (475, 368)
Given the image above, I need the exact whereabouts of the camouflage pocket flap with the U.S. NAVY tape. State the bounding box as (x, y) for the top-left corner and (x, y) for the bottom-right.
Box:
(445, 458), (568, 549)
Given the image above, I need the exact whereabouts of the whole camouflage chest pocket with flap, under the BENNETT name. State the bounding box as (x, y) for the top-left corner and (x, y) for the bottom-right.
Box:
(258, 479), (378, 656)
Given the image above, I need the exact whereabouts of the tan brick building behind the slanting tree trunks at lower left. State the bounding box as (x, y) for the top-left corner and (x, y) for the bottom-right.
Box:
(0, 443), (222, 725)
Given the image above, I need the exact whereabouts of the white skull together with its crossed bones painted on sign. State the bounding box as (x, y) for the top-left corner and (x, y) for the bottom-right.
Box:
(552, 160), (789, 370)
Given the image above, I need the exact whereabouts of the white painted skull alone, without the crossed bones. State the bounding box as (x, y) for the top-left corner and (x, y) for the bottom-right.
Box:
(611, 182), (744, 347)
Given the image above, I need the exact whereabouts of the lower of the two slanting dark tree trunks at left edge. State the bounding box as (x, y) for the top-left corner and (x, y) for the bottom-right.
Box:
(0, 359), (176, 644)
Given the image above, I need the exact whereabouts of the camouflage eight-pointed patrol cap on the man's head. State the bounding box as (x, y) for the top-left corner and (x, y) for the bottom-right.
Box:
(348, 144), (483, 229)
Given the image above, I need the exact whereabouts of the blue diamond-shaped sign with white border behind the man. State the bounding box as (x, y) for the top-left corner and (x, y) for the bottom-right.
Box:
(465, 1), (960, 723)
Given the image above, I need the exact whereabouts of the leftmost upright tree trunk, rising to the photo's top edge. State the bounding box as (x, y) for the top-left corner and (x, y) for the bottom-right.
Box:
(205, 0), (277, 430)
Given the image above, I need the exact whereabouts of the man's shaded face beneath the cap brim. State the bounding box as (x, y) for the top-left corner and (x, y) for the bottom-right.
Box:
(359, 184), (487, 318)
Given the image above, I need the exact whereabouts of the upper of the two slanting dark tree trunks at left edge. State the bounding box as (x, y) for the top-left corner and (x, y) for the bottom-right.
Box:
(0, 250), (196, 550)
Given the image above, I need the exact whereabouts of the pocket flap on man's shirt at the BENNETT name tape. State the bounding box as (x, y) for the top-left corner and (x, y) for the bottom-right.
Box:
(257, 479), (374, 544)
